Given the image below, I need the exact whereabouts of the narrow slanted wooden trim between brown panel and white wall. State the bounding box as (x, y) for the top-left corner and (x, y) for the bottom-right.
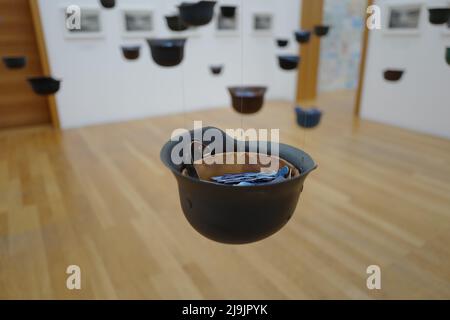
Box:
(29, 0), (60, 129)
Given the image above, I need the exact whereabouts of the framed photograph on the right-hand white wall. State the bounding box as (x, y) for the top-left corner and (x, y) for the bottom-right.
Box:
(384, 3), (423, 35)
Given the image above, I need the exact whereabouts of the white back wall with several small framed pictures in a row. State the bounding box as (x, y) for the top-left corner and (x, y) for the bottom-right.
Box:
(39, 0), (301, 128)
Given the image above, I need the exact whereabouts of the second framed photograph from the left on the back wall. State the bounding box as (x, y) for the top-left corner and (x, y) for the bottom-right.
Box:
(122, 8), (154, 37)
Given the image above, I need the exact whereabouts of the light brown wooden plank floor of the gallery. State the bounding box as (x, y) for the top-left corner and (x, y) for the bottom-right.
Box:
(0, 93), (450, 299)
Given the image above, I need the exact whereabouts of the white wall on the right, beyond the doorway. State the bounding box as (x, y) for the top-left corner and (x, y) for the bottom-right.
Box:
(361, 0), (450, 138)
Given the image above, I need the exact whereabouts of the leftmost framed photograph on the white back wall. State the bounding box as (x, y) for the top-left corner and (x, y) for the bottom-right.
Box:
(62, 7), (104, 39)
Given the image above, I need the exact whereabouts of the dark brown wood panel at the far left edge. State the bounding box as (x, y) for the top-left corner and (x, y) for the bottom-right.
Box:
(0, 0), (51, 128)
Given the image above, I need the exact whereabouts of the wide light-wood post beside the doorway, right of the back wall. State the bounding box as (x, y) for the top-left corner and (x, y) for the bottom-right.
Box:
(297, 0), (323, 102)
